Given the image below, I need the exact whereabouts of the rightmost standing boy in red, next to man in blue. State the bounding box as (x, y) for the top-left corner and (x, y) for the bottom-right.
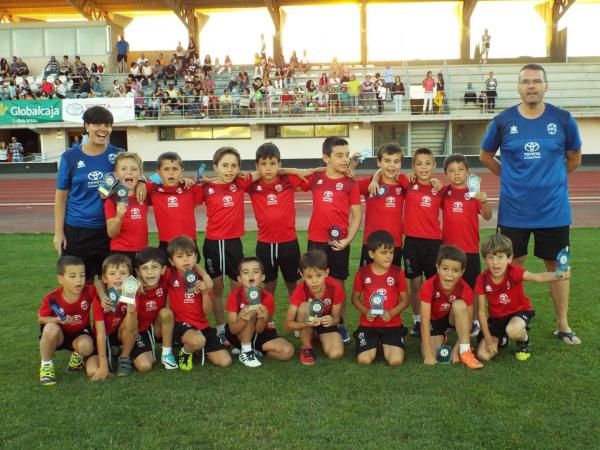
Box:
(442, 153), (492, 336)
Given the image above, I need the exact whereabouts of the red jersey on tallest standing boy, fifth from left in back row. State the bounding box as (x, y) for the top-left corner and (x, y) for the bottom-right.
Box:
(307, 172), (360, 242)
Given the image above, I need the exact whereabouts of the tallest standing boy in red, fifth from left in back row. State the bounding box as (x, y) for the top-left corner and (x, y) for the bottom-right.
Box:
(307, 136), (361, 344)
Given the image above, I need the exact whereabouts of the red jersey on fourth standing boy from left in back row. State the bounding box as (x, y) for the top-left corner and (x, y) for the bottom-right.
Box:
(247, 175), (306, 244)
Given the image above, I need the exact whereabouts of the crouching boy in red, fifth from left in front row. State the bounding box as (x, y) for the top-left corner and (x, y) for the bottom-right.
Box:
(225, 256), (294, 367)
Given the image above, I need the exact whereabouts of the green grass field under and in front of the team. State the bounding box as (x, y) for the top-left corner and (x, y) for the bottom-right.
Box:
(0, 229), (600, 449)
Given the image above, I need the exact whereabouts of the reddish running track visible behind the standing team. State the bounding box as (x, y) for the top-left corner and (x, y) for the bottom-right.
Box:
(0, 169), (600, 233)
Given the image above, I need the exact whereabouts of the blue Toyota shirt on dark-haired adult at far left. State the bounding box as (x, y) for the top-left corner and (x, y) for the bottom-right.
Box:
(56, 144), (123, 228)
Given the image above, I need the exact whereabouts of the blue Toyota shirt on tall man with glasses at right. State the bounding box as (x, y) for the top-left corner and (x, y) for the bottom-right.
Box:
(481, 103), (581, 228)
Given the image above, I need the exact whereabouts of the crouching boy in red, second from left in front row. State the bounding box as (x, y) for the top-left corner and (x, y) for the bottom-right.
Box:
(86, 253), (137, 381)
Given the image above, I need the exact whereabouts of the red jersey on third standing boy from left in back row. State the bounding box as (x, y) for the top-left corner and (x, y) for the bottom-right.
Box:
(202, 177), (252, 241)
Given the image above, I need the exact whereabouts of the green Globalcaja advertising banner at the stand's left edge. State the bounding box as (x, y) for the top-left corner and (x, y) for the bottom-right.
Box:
(0, 100), (62, 125)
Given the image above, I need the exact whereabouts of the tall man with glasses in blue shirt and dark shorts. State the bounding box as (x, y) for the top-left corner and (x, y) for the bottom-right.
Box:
(479, 64), (582, 345)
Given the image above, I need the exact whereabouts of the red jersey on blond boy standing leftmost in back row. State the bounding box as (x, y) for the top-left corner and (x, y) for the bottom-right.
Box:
(104, 195), (148, 252)
